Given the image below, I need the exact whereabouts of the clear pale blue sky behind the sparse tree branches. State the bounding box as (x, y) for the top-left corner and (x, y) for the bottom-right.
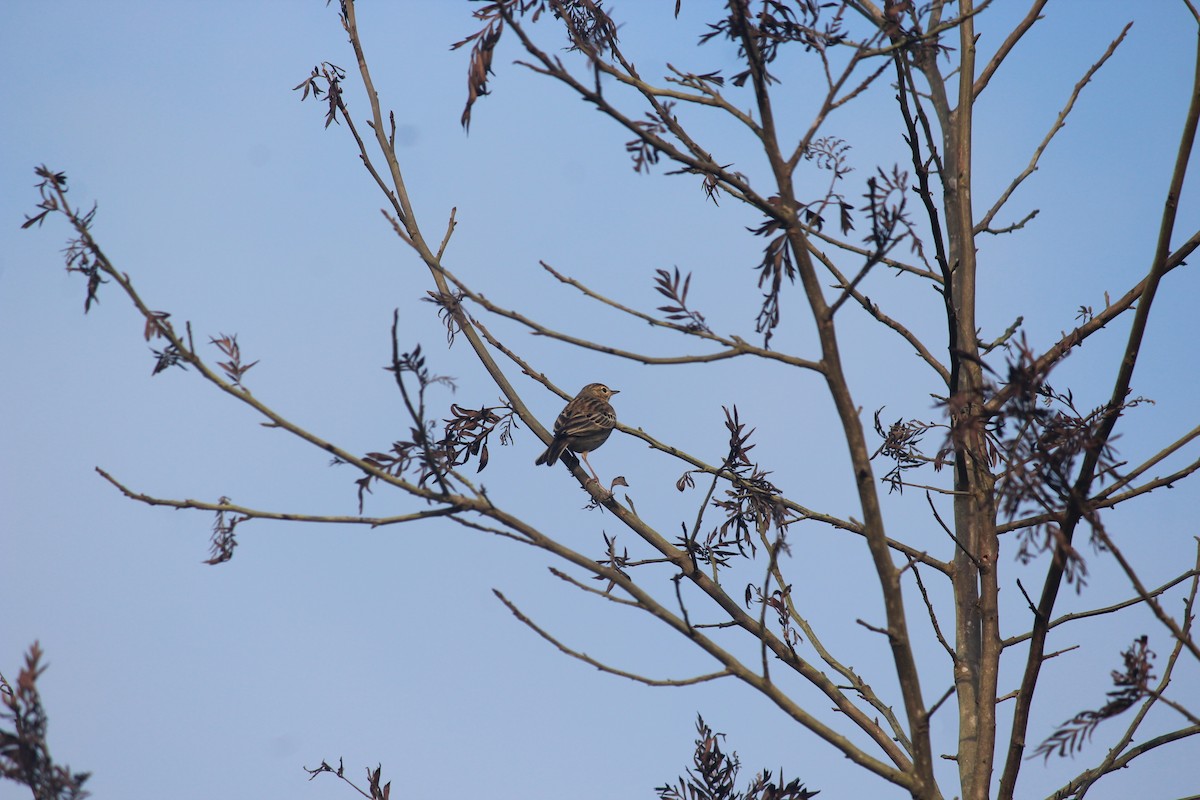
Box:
(0, 0), (1200, 800)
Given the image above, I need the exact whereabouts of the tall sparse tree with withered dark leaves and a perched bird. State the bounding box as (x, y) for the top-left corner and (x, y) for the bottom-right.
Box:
(11, 0), (1200, 798)
